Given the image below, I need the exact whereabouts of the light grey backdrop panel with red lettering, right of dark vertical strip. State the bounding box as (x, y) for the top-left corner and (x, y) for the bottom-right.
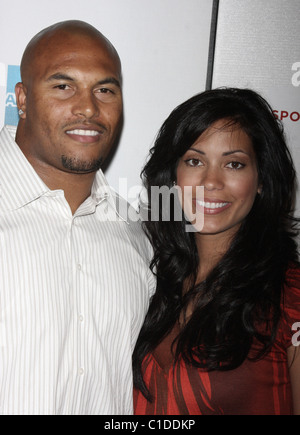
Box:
(212, 0), (300, 215)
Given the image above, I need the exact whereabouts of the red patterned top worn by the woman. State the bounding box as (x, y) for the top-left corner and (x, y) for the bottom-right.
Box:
(134, 269), (300, 415)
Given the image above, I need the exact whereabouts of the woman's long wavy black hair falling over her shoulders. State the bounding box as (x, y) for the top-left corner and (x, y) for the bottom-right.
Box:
(133, 88), (298, 400)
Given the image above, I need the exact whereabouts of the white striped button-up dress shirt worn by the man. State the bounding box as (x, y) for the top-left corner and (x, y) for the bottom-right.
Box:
(0, 127), (155, 415)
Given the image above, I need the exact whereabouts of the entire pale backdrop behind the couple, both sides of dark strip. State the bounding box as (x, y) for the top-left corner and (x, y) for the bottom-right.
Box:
(0, 0), (300, 210)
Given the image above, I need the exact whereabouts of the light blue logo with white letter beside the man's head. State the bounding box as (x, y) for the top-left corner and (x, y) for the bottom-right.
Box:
(4, 65), (21, 125)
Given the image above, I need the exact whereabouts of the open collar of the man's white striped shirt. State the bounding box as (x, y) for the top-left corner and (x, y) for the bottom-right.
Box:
(0, 126), (127, 222)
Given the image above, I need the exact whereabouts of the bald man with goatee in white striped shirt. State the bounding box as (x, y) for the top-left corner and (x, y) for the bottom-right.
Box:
(0, 21), (154, 415)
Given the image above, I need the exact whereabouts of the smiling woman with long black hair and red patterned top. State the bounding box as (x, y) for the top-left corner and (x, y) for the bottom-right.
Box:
(133, 89), (300, 415)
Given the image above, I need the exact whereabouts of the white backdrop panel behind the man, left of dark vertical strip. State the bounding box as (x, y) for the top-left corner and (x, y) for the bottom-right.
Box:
(0, 0), (212, 206)
